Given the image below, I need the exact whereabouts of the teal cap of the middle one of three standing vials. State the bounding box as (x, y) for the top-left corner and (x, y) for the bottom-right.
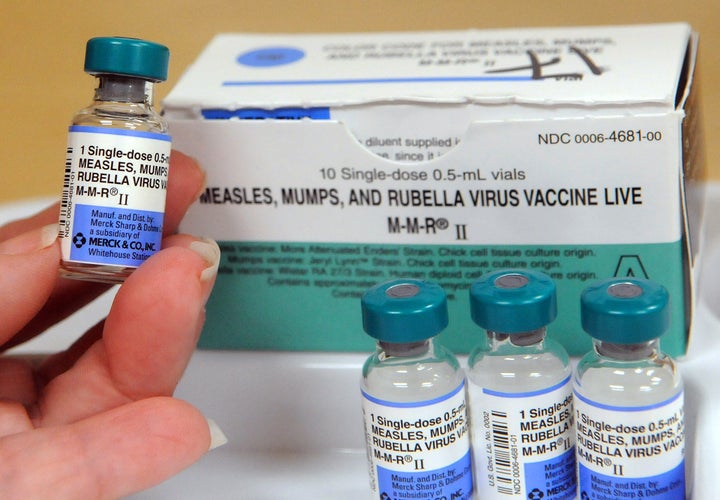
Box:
(470, 269), (557, 334)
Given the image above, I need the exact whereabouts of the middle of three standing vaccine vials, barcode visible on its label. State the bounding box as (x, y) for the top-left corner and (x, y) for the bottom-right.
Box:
(467, 270), (577, 500)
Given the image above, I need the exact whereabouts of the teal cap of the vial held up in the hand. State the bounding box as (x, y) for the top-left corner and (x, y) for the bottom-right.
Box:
(85, 37), (170, 82)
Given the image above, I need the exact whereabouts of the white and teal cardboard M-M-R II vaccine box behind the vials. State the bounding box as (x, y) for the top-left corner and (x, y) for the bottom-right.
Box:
(164, 23), (702, 355)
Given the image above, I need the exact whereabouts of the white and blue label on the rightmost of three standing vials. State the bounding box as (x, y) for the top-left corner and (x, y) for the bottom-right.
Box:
(575, 391), (685, 500)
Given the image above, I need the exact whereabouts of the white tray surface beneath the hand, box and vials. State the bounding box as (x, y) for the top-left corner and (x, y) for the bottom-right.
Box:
(0, 184), (720, 500)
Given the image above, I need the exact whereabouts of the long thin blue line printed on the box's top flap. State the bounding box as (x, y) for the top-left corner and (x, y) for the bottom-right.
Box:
(222, 76), (533, 87)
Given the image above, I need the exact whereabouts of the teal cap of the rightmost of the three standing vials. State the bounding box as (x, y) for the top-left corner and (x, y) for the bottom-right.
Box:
(580, 278), (670, 344)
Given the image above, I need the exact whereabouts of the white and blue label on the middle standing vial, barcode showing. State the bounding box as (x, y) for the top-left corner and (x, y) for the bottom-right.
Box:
(470, 376), (577, 500)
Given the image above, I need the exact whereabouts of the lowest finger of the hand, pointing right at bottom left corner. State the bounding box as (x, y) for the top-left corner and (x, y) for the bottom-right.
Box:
(0, 397), (210, 499)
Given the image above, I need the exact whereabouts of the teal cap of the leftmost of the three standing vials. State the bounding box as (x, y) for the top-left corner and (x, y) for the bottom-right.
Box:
(361, 279), (448, 344)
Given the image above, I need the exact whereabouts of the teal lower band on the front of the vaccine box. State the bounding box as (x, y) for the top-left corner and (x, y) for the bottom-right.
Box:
(200, 241), (687, 356)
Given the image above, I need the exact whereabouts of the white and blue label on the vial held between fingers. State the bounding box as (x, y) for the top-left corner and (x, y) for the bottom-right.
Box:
(60, 126), (171, 267)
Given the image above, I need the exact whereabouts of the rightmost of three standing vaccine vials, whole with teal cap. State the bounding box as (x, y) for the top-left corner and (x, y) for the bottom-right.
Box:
(574, 278), (685, 500)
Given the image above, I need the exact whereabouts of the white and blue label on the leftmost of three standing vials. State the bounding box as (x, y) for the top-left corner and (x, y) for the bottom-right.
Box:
(362, 382), (473, 500)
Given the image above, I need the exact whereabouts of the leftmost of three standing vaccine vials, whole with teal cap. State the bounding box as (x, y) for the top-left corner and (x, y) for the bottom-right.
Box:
(361, 280), (473, 499)
